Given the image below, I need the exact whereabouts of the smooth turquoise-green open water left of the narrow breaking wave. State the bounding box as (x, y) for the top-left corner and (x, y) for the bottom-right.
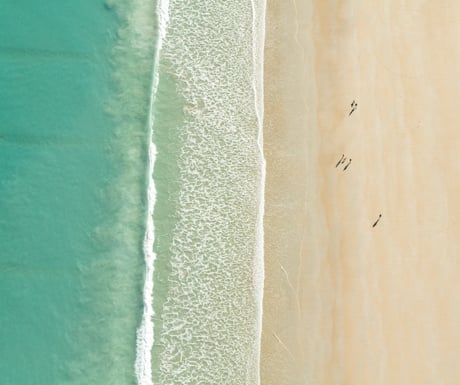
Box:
(0, 0), (155, 385)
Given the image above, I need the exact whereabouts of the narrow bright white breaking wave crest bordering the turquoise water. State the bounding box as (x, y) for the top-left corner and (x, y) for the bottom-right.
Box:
(135, 0), (169, 385)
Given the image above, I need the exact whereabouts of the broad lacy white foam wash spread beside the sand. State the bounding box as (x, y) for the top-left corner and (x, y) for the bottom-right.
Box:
(154, 0), (265, 385)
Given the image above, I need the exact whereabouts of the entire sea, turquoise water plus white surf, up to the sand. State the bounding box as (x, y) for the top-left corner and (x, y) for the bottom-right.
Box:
(0, 0), (264, 385)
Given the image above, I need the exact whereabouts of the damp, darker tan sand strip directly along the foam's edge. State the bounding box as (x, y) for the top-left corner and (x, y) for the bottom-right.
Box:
(261, 0), (323, 385)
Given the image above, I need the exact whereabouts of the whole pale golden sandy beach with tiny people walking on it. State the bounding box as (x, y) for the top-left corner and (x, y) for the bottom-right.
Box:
(261, 0), (460, 385)
